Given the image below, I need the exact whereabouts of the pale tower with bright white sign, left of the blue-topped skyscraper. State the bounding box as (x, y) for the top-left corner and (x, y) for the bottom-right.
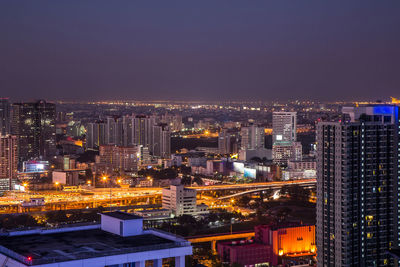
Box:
(272, 112), (297, 144)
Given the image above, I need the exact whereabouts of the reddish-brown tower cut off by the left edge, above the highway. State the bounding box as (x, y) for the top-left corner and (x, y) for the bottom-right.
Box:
(0, 135), (18, 191)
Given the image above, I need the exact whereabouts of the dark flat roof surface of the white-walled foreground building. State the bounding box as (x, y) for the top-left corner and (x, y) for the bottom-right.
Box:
(0, 228), (182, 265)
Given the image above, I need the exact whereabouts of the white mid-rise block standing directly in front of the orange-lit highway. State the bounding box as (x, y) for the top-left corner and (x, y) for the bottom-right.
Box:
(162, 185), (208, 216)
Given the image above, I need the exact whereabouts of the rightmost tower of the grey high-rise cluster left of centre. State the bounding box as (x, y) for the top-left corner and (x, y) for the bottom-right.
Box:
(153, 123), (171, 158)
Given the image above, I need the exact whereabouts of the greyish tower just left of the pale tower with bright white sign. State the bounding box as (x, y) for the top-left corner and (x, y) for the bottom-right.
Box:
(240, 124), (265, 150)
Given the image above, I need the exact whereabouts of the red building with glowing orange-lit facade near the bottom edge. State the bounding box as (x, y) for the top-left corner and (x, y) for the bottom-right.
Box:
(218, 225), (316, 266)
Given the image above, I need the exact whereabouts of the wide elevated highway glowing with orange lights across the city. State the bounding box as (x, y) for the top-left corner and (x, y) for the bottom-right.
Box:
(0, 179), (316, 216)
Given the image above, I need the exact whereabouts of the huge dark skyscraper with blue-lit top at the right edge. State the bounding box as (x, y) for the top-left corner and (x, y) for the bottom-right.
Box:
(316, 105), (400, 266)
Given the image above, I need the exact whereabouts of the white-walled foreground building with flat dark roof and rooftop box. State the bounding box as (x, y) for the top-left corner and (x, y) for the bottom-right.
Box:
(0, 211), (192, 267)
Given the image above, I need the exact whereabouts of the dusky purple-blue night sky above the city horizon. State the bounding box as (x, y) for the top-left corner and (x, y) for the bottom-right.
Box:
(0, 0), (400, 101)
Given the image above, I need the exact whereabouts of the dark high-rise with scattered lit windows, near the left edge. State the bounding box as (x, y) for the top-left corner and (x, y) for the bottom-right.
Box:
(12, 100), (56, 160)
